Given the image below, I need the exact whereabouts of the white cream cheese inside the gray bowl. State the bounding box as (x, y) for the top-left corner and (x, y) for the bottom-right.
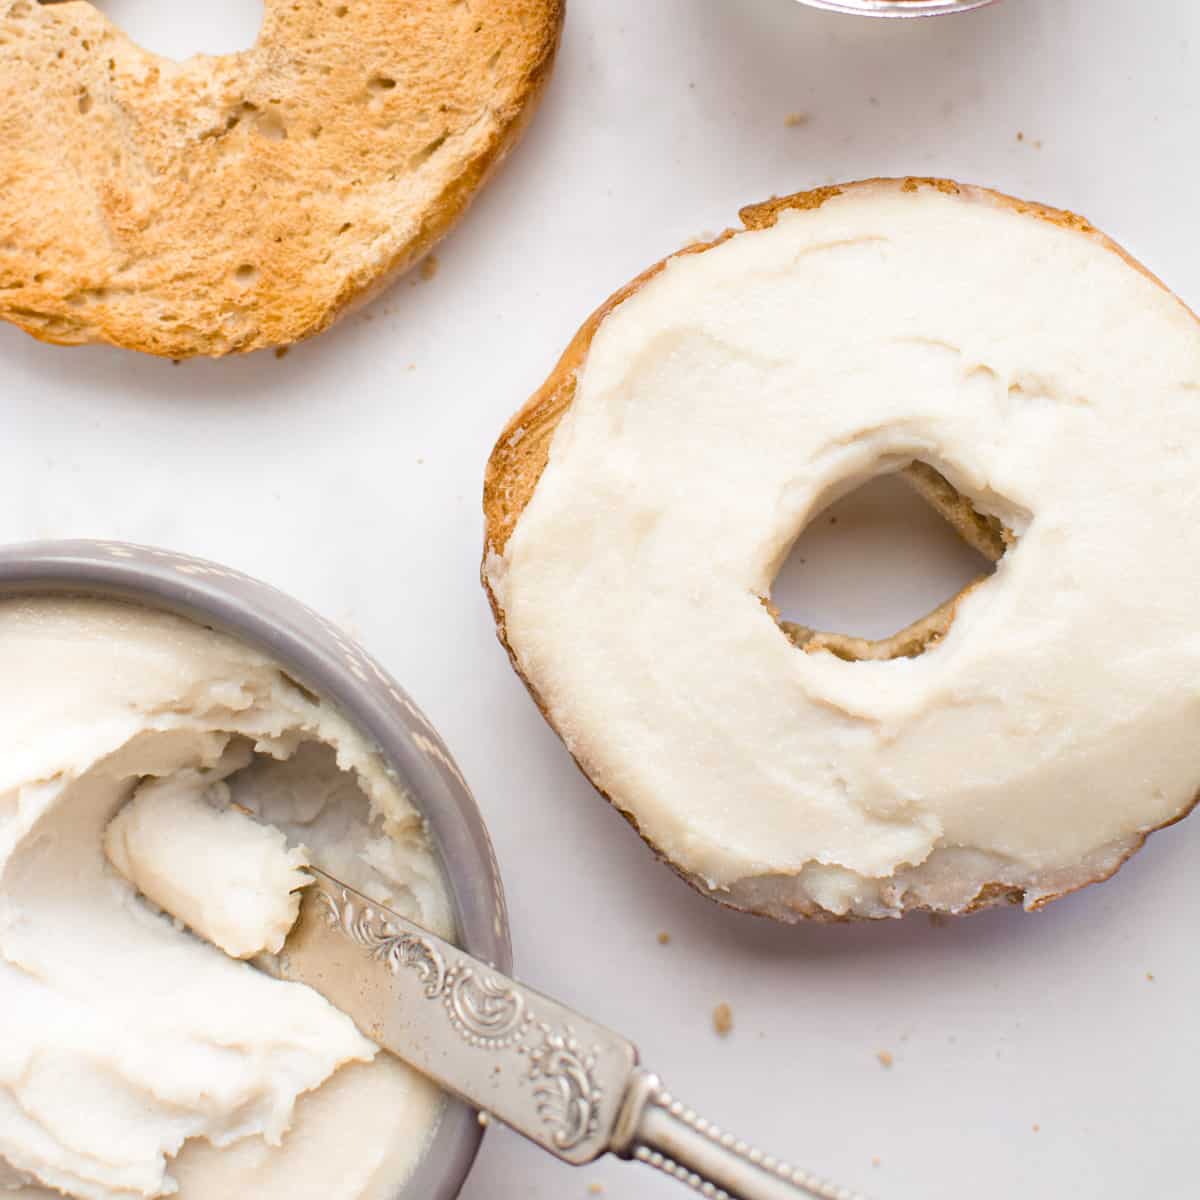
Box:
(0, 599), (452, 1200)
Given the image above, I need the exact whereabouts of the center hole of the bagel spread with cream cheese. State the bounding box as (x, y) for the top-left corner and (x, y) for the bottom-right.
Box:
(769, 463), (1003, 660)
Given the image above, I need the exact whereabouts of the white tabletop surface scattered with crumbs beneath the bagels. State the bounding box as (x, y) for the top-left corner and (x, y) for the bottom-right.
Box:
(0, 0), (1200, 1200)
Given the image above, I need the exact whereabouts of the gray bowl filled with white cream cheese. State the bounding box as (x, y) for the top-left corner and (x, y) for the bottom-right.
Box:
(0, 541), (511, 1200)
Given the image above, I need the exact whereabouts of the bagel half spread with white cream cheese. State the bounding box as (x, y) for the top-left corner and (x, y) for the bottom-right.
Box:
(484, 179), (1200, 920)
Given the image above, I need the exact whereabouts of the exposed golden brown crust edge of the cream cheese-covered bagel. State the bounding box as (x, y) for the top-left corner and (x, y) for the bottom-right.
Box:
(481, 176), (1200, 924)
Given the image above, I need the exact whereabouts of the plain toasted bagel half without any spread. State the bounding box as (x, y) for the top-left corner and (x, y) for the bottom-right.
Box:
(0, 0), (563, 358)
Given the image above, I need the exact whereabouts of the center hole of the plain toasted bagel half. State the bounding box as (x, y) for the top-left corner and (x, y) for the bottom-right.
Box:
(95, 0), (264, 60)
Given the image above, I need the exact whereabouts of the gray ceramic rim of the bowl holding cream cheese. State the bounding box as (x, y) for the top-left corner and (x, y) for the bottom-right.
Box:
(0, 541), (512, 1200)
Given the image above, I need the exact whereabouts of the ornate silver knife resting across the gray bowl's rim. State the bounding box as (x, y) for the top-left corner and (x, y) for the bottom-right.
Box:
(273, 868), (856, 1200)
